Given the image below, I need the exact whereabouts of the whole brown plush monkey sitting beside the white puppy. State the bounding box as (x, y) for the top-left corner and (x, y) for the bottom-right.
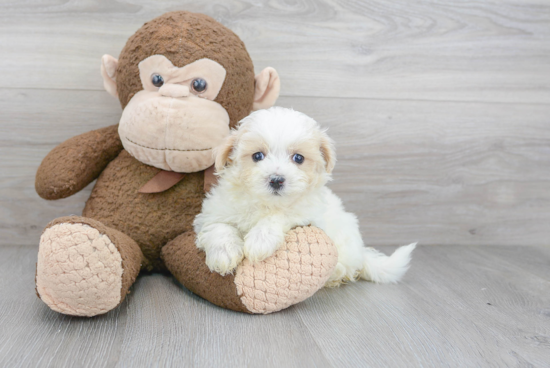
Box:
(36, 12), (337, 316)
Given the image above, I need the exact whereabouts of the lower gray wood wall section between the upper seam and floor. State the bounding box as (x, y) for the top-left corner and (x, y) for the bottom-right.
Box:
(0, 89), (550, 246)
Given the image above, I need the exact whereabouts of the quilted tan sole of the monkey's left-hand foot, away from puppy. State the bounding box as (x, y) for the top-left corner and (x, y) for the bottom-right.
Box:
(36, 223), (123, 317)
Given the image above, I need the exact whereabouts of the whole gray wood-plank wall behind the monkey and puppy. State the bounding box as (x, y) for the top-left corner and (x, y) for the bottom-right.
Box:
(0, 0), (550, 246)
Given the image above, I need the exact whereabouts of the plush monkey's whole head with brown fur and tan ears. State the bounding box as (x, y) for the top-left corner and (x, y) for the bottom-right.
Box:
(101, 11), (280, 172)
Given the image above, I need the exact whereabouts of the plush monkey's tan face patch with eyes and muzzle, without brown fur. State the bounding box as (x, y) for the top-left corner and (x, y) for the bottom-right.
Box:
(118, 55), (229, 172)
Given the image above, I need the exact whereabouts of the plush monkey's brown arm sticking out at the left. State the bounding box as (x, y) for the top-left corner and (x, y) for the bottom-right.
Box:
(35, 125), (122, 199)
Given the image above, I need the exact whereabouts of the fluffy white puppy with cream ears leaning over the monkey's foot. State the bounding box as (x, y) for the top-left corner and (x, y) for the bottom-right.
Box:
(194, 107), (416, 286)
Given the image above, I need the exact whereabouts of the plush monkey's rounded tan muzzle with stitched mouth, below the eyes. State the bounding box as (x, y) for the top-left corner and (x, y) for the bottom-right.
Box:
(118, 91), (229, 172)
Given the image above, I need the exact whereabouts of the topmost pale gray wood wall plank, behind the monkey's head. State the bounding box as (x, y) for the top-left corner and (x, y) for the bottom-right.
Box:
(0, 0), (550, 103)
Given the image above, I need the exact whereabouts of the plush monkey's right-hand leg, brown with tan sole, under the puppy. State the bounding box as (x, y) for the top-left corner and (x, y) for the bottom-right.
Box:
(162, 226), (338, 314)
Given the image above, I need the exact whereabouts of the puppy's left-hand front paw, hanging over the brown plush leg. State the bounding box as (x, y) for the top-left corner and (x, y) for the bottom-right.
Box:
(206, 237), (243, 276)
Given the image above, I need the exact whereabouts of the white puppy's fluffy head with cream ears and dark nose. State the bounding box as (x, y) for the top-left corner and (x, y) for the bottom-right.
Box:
(216, 107), (336, 200)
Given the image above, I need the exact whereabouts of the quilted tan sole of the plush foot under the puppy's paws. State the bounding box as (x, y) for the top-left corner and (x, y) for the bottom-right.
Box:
(235, 226), (338, 314)
